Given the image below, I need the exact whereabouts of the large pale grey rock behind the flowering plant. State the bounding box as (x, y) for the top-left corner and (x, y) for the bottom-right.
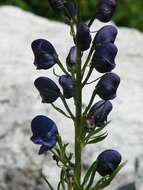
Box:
(0, 7), (143, 190)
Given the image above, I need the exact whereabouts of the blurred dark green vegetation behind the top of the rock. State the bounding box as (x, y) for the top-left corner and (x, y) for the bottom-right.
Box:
(0, 0), (143, 31)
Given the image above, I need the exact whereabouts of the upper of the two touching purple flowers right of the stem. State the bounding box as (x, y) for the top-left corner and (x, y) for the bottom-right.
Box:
(93, 25), (118, 46)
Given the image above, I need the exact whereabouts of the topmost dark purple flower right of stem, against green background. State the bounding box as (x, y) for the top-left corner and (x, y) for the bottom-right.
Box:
(96, 0), (116, 22)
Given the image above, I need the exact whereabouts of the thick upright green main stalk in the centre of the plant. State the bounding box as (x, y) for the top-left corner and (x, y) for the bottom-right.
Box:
(74, 0), (82, 190)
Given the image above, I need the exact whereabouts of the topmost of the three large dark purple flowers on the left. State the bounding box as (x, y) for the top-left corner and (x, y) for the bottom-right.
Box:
(31, 39), (57, 69)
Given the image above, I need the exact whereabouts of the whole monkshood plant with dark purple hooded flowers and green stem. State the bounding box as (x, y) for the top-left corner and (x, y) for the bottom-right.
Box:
(31, 0), (125, 190)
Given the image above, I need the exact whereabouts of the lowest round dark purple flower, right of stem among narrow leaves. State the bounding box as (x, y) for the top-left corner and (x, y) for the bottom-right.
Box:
(97, 149), (122, 176)
